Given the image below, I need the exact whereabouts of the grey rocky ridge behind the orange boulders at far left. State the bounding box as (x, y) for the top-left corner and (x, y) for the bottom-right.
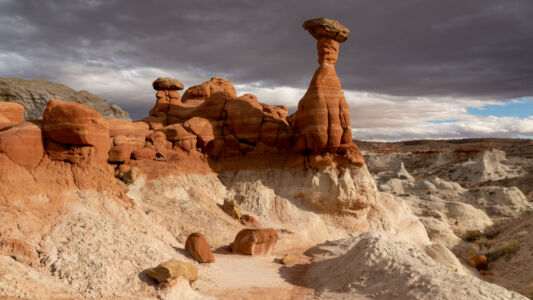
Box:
(0, 78), (130, 120)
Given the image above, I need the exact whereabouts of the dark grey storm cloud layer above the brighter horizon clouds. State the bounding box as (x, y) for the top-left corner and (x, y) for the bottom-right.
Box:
(0, 0), (533, 99)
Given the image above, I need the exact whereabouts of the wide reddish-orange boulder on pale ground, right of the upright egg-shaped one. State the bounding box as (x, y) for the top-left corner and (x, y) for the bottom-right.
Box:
(231, 228), (278, 255)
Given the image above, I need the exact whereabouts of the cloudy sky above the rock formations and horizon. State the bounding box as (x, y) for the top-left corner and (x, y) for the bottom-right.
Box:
(0, 0), (533, 141)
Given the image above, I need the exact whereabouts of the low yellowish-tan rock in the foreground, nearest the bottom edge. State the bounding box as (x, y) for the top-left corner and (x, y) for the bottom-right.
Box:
(146, 260), (198, 283)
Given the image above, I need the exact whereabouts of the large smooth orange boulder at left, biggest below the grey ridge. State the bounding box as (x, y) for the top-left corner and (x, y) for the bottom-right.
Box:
(43, 100), (111, 161)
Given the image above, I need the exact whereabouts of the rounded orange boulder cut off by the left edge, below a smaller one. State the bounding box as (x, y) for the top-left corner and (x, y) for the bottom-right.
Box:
(0, 122), (44, 168)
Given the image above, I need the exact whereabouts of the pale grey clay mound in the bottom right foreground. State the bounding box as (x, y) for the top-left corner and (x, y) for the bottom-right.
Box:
(306, 232), (526, 300)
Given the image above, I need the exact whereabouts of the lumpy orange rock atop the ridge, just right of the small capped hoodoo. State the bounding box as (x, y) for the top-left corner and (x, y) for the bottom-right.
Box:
(182, 77), (237, 102)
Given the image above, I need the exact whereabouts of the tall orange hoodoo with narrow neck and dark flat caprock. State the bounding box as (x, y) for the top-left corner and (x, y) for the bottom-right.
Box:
(296, 18), (352, 152)
